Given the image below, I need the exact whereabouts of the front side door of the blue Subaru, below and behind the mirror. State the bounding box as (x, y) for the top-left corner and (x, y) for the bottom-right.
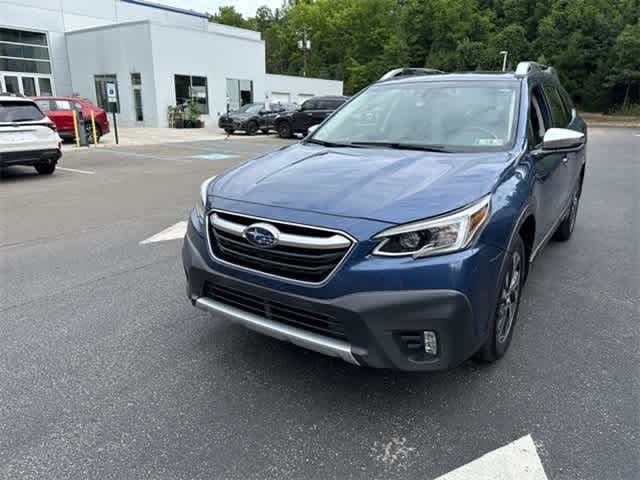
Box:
(527, 85), (565, 243)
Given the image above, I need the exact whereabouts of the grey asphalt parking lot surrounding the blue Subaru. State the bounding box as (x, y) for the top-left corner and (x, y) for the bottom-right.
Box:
(0, 128), (640, 480)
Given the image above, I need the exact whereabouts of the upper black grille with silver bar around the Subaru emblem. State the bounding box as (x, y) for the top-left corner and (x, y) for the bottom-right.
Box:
(208, 212), (353, 283)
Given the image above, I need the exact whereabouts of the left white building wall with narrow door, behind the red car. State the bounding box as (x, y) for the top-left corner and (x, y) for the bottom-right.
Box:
(67, 22), (159, 126)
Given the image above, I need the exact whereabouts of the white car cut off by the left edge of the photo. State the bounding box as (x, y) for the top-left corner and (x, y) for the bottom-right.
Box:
(0, 93), (62, 175)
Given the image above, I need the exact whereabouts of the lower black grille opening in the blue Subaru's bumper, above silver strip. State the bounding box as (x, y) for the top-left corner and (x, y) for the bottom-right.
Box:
(203, 282), (347, 341)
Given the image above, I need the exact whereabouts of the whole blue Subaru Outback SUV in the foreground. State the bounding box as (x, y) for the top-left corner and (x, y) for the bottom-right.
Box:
(182, 62), (586, 371)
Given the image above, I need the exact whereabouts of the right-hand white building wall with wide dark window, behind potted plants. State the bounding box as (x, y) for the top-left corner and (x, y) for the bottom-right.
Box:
(151, 24), (267, 127)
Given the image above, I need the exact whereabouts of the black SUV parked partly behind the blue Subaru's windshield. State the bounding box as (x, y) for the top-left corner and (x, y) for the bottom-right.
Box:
(274, 96), (348, 138)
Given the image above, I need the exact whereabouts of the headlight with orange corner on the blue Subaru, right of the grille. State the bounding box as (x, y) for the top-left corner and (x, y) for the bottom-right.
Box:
(373, 195), (491, 258)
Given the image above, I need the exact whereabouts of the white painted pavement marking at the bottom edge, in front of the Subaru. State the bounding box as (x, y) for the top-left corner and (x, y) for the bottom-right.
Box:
(436, 435), (548, 480)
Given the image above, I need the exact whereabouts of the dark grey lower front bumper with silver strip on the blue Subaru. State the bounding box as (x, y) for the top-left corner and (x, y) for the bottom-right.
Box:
(182, 219), (498, 371)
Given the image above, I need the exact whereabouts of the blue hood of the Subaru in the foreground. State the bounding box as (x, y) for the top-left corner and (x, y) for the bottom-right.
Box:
(209, 144), (511, 223)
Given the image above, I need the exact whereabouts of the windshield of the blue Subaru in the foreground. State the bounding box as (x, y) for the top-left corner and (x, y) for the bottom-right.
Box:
(312, 81), (519, 151)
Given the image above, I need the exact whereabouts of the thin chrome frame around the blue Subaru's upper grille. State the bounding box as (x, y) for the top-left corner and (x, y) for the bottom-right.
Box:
(204, 208), (358, 287)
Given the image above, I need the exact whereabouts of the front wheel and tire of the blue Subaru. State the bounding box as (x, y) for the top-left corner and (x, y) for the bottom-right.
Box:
(475, 235), (526, 362)
